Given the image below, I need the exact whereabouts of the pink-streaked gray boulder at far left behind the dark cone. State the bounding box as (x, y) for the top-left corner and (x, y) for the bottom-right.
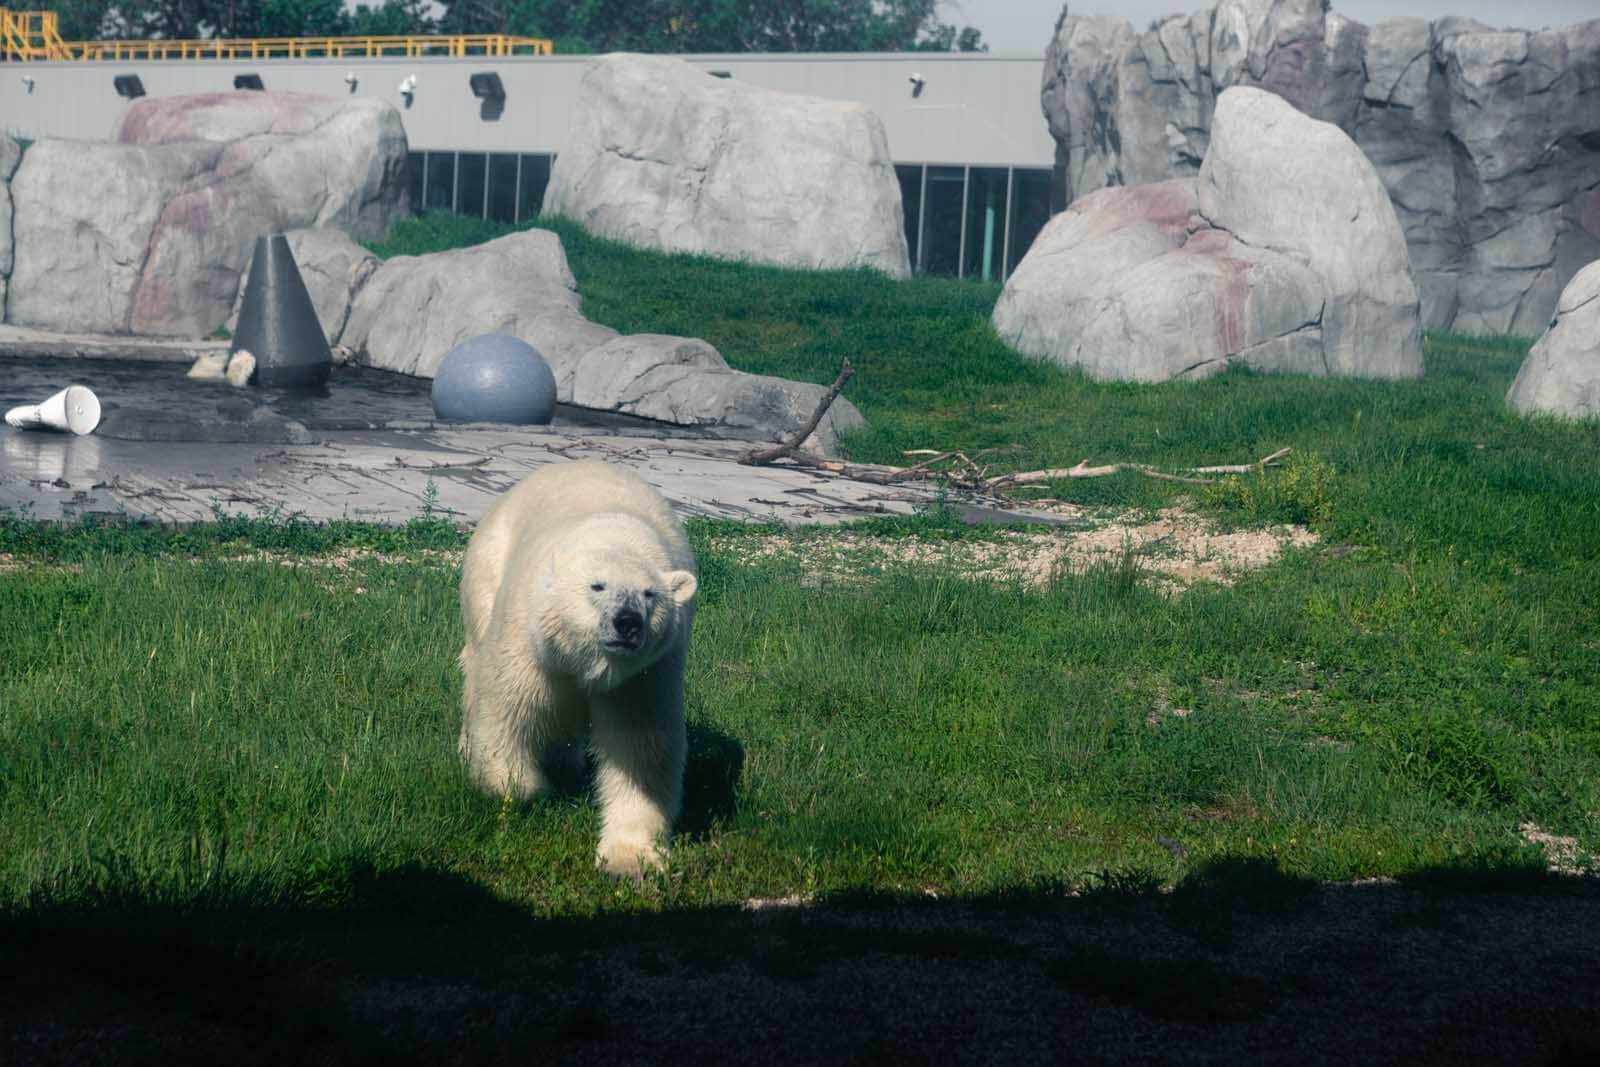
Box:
(6, 93), (408, 338)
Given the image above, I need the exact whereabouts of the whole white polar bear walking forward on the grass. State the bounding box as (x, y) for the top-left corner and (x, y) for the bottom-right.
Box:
(459, 461), (698, 880)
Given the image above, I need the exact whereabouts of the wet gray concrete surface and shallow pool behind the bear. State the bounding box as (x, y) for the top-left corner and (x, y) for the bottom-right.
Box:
(0, 347), (1059, 523)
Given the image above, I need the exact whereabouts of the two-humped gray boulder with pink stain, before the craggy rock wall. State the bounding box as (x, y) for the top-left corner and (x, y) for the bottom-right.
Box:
(994, 88), (1422, 382)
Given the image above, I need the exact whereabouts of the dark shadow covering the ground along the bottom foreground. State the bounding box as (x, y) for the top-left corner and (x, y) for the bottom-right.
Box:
(0, 857), (1600, 1065)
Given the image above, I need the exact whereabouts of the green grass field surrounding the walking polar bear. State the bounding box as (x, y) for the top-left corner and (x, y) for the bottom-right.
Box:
(0, 218), (1600, 1062)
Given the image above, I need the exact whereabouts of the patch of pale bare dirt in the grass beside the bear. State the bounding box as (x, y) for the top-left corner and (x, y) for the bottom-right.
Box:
(712, 507), (1317, 592)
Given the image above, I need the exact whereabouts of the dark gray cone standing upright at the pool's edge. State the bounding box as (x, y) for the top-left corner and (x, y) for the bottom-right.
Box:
(232, 234), (333, 389)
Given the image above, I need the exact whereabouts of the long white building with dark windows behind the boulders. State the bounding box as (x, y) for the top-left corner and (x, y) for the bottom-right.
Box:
(0, 53), (1054, 278)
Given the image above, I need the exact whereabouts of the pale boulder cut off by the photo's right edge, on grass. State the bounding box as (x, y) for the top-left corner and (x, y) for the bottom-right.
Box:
(1506, 259), (1600, 419)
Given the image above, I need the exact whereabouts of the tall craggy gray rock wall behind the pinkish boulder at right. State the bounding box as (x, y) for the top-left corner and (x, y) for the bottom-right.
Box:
(1042, 0), (1600, 334)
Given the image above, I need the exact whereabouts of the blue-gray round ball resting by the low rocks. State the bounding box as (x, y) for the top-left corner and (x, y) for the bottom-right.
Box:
(434, 333), (555, 426)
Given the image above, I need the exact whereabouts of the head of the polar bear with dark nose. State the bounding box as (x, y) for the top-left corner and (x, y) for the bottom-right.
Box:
(544, 544), (698, 688)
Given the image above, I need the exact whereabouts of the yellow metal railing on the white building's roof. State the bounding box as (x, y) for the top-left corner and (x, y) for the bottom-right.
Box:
(0, 8), (552, 61)
